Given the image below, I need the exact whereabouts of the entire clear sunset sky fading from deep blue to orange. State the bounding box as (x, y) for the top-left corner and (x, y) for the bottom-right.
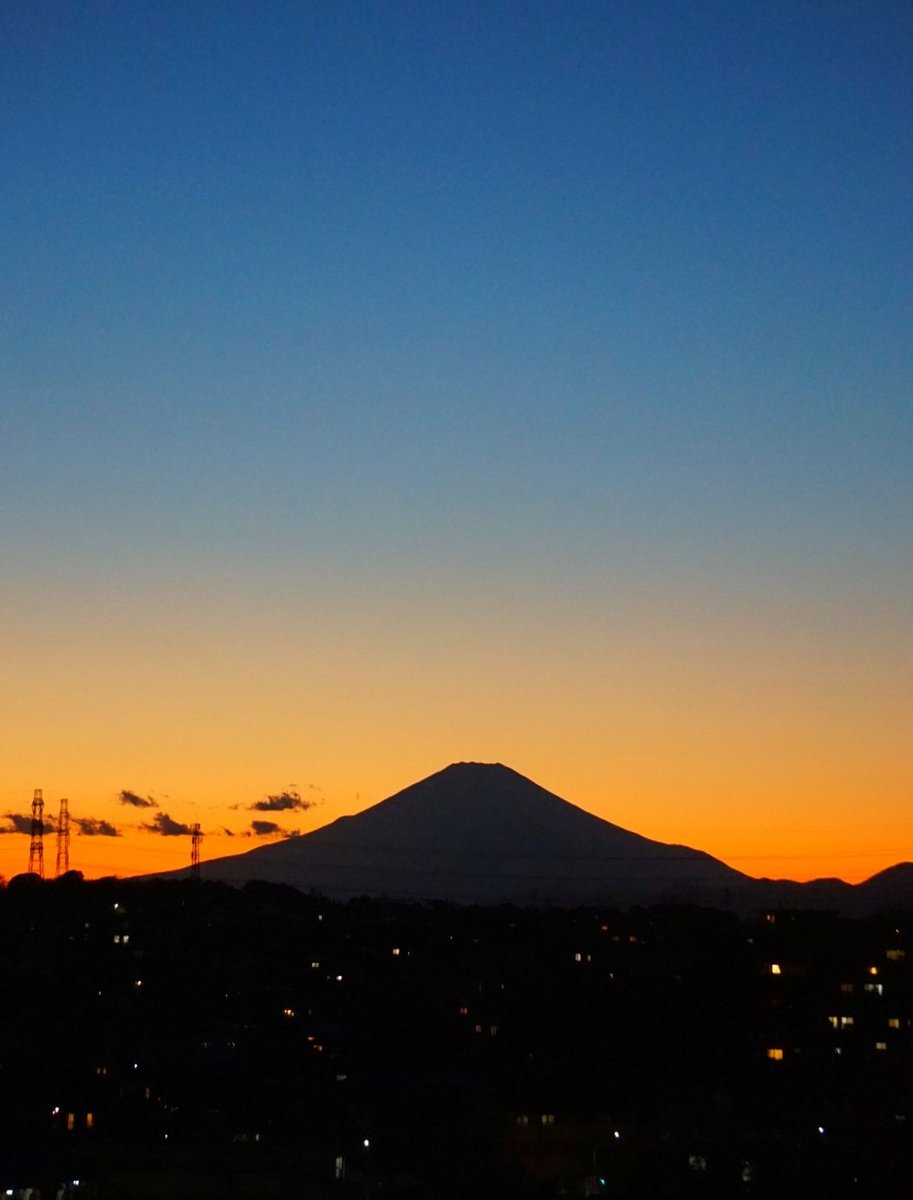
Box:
(0, 0), (913, 881)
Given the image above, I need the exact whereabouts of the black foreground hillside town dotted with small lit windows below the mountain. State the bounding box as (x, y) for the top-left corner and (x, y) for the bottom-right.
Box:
(0, 877), (913, 1200)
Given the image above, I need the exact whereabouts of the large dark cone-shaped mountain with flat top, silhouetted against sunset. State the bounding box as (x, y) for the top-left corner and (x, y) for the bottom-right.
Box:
(164, 762), (747, 905)
